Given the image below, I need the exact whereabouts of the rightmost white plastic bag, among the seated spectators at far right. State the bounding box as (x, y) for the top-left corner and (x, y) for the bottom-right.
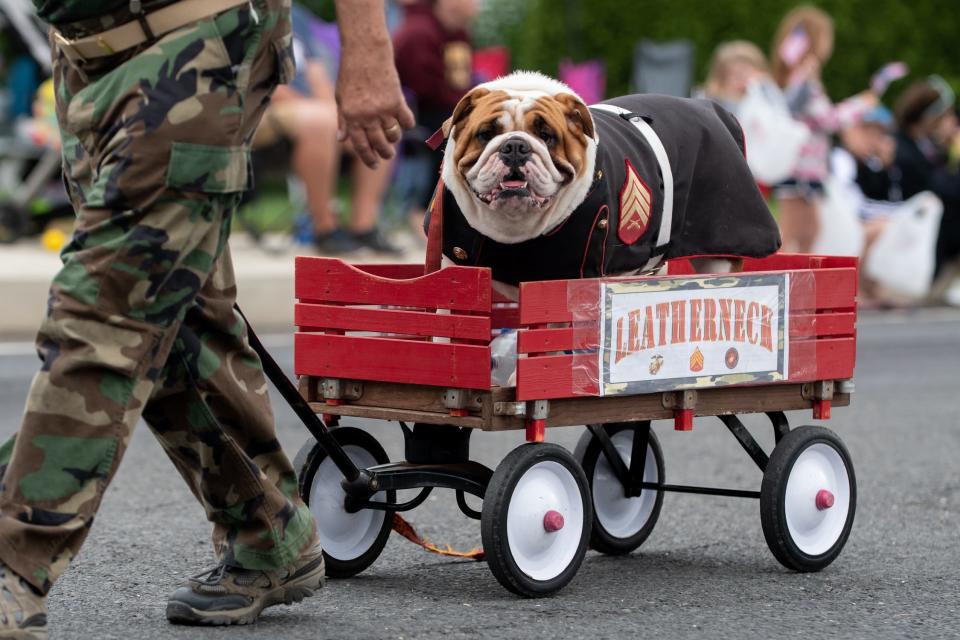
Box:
(863, 191), (943, 300)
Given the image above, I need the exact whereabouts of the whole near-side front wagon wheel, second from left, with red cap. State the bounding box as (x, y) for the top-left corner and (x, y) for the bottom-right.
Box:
(480, 443), (592, 598)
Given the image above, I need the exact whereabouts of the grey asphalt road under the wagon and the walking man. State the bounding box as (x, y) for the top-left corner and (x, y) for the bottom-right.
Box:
(0, 311), (960, 639)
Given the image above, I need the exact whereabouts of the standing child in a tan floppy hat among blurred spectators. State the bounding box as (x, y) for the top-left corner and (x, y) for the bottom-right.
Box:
(771, 6), (878, 253)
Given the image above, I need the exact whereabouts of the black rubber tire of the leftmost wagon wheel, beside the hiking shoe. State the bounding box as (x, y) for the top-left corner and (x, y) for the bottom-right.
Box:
(294, 427), (396, 578)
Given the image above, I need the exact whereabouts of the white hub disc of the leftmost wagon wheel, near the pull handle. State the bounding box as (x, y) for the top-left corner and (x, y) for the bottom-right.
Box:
(310, 445), (386, 561)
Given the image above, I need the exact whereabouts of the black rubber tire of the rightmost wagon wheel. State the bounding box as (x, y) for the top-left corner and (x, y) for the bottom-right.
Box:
(760, 426), (857, 573)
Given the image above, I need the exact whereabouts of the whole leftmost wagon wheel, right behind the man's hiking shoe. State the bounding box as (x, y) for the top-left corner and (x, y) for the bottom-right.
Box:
(294, 427), (396, 578)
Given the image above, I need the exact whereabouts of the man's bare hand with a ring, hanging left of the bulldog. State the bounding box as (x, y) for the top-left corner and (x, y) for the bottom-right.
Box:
(337, 42), (415, 168)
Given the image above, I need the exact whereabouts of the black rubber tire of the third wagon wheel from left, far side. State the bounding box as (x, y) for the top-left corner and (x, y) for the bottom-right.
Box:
(573, 424), (666, 556)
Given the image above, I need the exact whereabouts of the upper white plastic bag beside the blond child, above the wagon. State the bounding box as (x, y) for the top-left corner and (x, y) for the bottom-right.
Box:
(736, 81), (810, 185)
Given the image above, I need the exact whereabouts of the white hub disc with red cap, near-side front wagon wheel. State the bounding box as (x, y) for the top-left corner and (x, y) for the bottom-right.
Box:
(507, 460), (584, 580)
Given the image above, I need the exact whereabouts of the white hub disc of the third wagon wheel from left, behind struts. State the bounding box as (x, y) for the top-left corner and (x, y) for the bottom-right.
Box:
(593, 429), (660, 538)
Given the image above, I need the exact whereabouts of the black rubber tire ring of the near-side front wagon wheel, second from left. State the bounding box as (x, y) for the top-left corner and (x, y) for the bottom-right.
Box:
(480, 443), (593, 598)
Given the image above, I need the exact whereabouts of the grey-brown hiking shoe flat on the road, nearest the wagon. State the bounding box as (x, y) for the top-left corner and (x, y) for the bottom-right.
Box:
(167, 546), (324, 625)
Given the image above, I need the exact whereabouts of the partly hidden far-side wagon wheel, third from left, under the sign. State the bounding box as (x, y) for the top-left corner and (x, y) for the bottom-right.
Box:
(574, 424), (664, 555)
